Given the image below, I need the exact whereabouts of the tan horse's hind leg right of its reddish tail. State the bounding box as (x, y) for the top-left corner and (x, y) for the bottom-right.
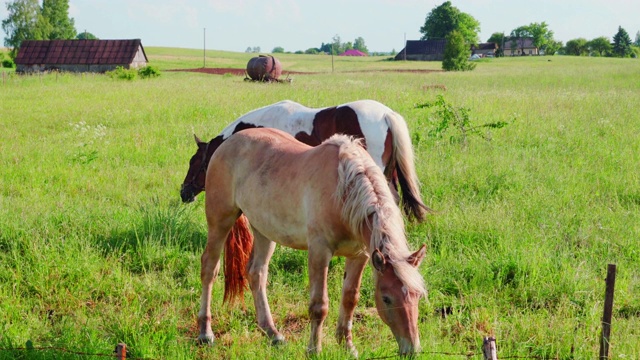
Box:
(247, 229), (284, 345)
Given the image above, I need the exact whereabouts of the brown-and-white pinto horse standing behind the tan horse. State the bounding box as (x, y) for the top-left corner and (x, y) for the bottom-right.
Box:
(180, 100), (431, 221)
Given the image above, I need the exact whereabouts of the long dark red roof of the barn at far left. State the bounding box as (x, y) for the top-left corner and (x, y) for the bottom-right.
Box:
(15, 39), (147, 65)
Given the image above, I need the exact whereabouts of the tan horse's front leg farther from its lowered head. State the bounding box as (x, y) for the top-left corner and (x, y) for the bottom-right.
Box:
(307, 245), (333, 354)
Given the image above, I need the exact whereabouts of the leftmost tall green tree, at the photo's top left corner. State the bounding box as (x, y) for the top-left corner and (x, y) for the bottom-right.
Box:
(2, 0), (44, 59)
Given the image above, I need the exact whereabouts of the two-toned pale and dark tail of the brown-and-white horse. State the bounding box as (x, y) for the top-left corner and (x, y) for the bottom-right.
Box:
(386, 112), (433, 221)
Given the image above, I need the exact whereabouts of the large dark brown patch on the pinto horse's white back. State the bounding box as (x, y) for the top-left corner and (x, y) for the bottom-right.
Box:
(295, 106), (367, 148)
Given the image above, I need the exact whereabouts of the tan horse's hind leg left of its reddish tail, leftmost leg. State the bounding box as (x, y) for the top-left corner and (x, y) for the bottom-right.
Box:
(198, 212), (235, 344)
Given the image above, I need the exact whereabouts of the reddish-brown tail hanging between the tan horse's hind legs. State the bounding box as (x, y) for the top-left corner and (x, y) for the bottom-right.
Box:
(223, 215), (253, 302)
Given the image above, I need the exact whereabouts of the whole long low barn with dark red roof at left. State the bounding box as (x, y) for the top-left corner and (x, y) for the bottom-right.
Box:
(15, 39), (148, 73)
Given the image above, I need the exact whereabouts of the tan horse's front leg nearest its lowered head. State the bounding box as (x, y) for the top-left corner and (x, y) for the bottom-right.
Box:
(336, 254), (369, 357)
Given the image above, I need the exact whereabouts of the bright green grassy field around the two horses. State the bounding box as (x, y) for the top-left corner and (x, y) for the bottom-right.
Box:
(0, 48), (640, 359)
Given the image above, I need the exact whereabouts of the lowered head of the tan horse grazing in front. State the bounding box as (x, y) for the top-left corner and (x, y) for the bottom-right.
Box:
(371, 245), (425, 355)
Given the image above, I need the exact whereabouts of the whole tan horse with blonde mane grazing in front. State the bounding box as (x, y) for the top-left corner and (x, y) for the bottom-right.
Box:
(198, 128), (426, 355)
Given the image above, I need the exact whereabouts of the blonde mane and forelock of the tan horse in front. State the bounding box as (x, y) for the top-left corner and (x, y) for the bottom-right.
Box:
(325, 135), (426, 294)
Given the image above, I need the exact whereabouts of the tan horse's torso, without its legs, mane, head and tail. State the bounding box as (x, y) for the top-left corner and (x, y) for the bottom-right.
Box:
(210, 128), (358, 249)
